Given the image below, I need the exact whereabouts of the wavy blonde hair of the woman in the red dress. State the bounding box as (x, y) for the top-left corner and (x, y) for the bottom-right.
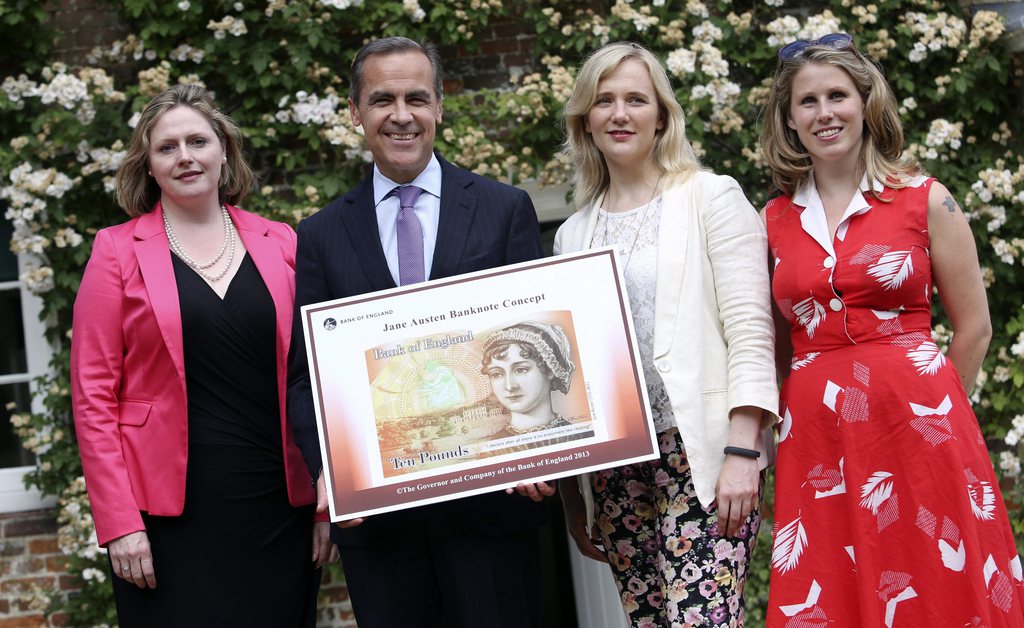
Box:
(761, 43), (921, 201)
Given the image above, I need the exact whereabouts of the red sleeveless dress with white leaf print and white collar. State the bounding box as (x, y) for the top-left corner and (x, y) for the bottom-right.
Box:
(765, 177), (1024, 628)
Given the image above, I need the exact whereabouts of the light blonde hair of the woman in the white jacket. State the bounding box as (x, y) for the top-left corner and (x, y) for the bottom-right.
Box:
(562, 42), (700, 209)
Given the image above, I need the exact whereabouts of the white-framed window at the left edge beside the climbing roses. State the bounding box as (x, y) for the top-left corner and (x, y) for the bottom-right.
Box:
(0, 213), (53, 512)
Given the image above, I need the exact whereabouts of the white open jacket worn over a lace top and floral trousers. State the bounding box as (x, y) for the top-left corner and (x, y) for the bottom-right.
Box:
(554, 171), (778, 507)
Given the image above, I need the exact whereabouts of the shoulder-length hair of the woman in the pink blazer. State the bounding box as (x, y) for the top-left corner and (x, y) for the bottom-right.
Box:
(114, 84), (256, 218)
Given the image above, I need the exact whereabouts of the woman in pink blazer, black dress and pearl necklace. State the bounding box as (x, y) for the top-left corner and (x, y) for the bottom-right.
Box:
(72, 85), (337, 626)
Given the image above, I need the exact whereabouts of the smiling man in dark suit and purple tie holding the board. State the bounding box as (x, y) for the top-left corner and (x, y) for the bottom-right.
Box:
(288, 37), (553, 628)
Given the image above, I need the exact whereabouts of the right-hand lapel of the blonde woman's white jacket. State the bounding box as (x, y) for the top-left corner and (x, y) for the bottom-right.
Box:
(654, 177), (699, 359)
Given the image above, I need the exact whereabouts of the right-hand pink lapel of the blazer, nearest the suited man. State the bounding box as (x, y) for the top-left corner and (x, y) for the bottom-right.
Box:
(227, 205), (295, 372)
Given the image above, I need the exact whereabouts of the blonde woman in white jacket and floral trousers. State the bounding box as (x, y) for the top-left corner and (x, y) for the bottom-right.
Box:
(555, 42), (778, 626)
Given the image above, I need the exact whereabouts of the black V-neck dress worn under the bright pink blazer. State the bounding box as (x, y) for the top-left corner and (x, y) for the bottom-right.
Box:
(114, 254), (319, 628)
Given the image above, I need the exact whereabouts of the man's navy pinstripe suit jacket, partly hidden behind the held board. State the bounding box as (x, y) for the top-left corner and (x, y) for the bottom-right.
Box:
(288, 156), (545, 545)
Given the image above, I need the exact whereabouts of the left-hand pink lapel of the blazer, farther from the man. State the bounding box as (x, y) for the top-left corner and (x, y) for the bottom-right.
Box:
(135, 203), (185, 386)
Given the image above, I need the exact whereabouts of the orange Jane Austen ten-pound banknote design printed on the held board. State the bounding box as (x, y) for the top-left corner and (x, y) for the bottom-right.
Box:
(366, 310), (594, 478)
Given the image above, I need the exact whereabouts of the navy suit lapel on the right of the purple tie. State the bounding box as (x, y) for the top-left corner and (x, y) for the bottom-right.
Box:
(425, 156), (477, 279)
